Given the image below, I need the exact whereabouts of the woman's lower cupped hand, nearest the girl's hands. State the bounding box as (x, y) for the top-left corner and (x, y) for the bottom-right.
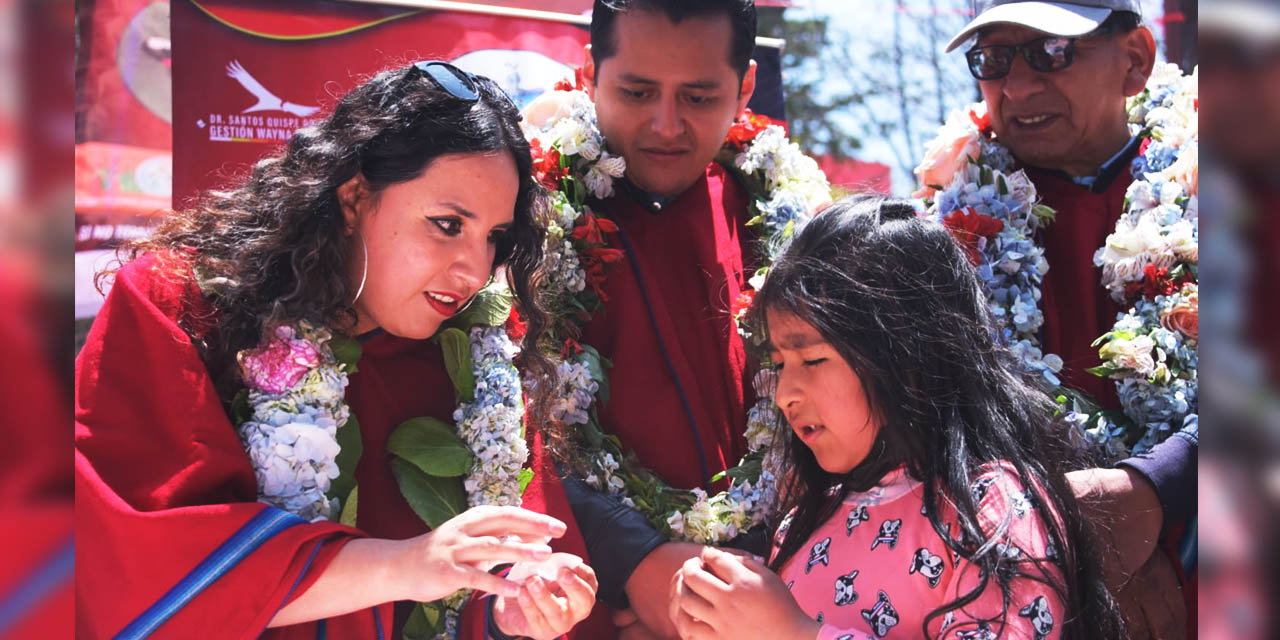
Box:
(493, 553), (598, 640)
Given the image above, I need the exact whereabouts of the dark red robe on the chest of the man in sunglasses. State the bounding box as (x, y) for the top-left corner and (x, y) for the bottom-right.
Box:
(1027, 168), (1133, 410)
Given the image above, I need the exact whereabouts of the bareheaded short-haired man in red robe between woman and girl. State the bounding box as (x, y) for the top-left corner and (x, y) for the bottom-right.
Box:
(547, 0), (759, 637)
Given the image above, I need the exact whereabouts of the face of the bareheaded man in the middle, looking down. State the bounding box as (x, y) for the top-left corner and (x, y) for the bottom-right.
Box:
(584, 12), (755, 196)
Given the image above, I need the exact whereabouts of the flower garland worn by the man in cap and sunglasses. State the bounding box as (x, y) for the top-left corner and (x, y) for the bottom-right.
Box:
(915, 64), (1199, 460)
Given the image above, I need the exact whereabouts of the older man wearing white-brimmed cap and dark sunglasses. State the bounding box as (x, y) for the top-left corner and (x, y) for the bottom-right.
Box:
(947, 0), (1198, 637)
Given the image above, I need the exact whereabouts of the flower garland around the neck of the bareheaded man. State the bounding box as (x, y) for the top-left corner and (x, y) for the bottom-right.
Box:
(525, 77), (831, 544)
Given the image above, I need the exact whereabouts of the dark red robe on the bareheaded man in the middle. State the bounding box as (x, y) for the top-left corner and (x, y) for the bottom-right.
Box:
(582, 163), (756, 489)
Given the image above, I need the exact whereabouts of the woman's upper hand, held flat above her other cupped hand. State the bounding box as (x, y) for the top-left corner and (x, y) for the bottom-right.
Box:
(390, 506), (566, 602)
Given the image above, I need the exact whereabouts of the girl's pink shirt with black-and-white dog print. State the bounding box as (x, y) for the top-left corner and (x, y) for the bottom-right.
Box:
(773, 466), (1064, 640)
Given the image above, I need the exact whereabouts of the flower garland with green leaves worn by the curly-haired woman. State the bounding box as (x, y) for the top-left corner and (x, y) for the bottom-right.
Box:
(233, 293), (532, 639)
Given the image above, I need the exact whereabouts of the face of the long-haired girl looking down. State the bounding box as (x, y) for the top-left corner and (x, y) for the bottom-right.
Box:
(767, 311), (879, 474)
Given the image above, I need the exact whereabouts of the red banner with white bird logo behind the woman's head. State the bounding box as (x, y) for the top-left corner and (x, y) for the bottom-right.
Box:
(172, 0), (589, 206)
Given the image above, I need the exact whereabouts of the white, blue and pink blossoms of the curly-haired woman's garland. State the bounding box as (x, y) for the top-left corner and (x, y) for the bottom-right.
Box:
(238, 321), (531, 639)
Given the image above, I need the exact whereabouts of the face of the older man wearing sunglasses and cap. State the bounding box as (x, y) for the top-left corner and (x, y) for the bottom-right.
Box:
(978, 24), (1149, 175)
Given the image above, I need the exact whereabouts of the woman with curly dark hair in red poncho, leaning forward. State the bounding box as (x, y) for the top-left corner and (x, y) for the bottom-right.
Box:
(76, 61), (595, 637)
